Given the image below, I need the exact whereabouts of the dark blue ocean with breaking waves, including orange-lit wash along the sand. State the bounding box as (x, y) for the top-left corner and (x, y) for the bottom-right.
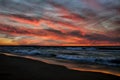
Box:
(0, 46), (120, 76)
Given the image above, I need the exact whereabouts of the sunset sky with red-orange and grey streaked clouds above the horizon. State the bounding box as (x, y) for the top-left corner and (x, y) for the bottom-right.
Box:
(0, 0), (120, 46)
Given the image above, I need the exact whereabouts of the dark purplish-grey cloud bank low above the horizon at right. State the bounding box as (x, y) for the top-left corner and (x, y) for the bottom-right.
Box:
(68, 30), (120, 42)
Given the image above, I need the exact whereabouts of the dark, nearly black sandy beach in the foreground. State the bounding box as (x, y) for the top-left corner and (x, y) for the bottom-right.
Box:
(0, 54), (120, 80)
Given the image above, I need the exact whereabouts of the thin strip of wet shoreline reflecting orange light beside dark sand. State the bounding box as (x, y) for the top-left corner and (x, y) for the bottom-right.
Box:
(2, 53), (120, 77)
